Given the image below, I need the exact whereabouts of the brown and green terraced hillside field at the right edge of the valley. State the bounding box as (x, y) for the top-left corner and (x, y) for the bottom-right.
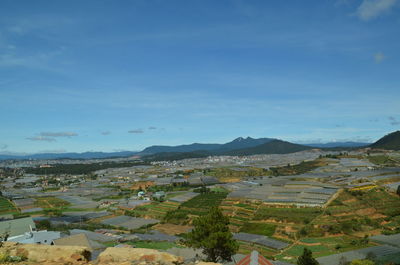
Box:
(301, 188), (400, 237)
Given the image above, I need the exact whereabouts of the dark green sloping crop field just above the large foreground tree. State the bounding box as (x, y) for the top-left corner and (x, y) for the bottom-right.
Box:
(164, 192), (228, 224)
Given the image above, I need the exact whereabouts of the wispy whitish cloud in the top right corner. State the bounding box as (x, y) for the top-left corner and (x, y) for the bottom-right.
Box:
(356, 0), (397, 21)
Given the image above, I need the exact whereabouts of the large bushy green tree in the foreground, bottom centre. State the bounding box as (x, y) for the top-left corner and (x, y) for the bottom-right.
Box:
(185, 207), (239, 262)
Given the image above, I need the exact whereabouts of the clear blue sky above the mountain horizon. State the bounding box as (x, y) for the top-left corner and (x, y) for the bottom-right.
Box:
(0, 0), (400, 153)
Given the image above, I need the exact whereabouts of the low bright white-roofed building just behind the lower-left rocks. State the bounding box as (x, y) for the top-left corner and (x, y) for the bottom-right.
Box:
(7, 230), (61, 245)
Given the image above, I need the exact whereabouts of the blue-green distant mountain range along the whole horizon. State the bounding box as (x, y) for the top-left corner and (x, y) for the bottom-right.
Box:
(0, 131), (400, 160)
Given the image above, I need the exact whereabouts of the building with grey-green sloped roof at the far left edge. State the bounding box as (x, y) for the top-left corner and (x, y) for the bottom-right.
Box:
(0, 217), (36, 237)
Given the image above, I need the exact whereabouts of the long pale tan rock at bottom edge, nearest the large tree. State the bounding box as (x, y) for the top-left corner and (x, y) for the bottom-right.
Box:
(97, 248), (183, 265)
